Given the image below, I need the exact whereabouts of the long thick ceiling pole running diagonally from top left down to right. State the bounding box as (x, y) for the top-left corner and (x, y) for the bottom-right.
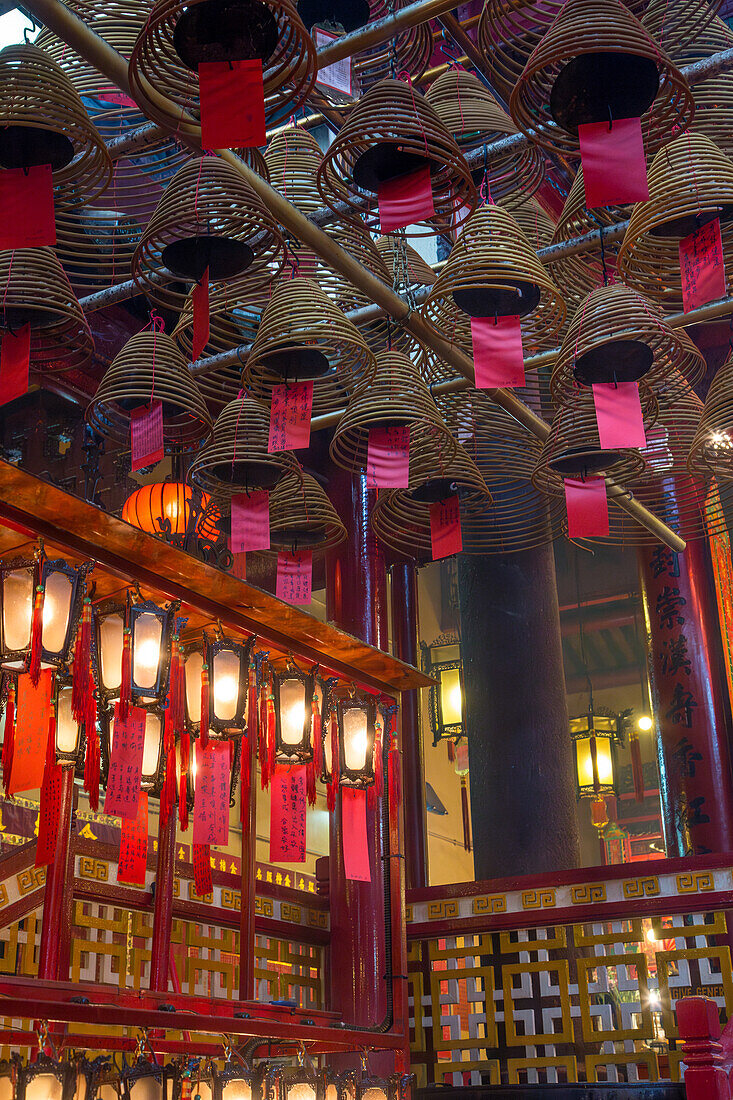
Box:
(22, 0), (685, 551)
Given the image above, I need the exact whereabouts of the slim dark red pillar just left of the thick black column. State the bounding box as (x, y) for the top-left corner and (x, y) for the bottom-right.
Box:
(391, 561), (428, 890)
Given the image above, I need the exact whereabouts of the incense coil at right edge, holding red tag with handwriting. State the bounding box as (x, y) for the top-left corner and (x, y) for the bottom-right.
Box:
(619, 132), (733, 311)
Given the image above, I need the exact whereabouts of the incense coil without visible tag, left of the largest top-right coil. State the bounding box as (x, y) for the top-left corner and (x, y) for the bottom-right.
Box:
(425, 67), (545, 209)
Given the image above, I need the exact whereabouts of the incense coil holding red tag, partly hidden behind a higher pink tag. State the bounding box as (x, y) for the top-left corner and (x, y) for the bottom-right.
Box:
(532, 389), (656, 495)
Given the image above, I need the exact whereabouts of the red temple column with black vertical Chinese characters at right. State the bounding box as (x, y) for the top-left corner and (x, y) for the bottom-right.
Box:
(638, 541), (733, 856)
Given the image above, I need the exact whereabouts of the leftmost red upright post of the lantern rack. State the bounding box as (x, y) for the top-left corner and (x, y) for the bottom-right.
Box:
(39, 767), (74, 981)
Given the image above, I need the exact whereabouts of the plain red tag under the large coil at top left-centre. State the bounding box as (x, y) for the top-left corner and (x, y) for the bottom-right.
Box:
(198, 57), (267, 150)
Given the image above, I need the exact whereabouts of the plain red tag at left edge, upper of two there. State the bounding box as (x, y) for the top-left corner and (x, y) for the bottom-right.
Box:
(0, 164), (56, 249)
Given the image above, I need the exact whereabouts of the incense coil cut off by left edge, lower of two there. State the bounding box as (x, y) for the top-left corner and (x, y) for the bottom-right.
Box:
(0, 249), (95, 373)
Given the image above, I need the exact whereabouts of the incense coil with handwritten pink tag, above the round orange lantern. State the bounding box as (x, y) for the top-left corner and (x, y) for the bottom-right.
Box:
(87, 329), (211, 451)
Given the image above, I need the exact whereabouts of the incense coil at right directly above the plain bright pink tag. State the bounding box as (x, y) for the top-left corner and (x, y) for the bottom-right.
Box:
(550, 283), (705, 403)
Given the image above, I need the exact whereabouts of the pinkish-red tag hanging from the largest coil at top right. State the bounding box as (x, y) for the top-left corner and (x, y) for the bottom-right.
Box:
(578, 119), (649, 210)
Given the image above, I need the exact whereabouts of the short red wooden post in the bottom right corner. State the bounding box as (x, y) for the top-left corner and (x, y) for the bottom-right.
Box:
(677, 997), (731, 1100)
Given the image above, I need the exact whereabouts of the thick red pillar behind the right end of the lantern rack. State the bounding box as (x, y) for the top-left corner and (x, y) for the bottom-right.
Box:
(326, 471), (387, 1026)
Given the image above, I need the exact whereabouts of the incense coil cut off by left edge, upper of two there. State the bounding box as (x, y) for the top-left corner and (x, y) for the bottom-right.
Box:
(0, 44), (112, 207)
